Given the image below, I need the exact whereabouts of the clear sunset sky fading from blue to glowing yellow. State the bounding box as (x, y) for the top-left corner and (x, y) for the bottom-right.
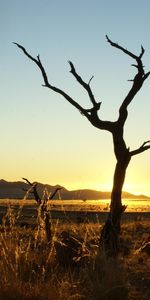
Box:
(0, 0), (150, 195)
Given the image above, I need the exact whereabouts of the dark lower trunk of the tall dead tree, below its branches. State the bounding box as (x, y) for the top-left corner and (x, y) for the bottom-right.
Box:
(100, 151), (131, 257)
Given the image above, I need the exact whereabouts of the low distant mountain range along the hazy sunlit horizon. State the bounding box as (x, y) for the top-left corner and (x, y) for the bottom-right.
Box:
(0, 179), (150, 200)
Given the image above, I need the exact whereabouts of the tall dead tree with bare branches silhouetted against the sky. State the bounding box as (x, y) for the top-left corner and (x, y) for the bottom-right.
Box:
(15, 36), (150, 255)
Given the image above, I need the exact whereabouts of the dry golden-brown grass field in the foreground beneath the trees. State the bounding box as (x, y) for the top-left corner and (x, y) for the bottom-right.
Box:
(0, 206), (150, 300)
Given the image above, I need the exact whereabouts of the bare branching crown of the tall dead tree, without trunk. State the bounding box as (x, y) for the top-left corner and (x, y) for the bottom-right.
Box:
(14, 35), (150, 157)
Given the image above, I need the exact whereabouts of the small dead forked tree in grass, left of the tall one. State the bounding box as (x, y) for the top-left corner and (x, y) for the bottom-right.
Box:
(22, 178), (62, 242)
